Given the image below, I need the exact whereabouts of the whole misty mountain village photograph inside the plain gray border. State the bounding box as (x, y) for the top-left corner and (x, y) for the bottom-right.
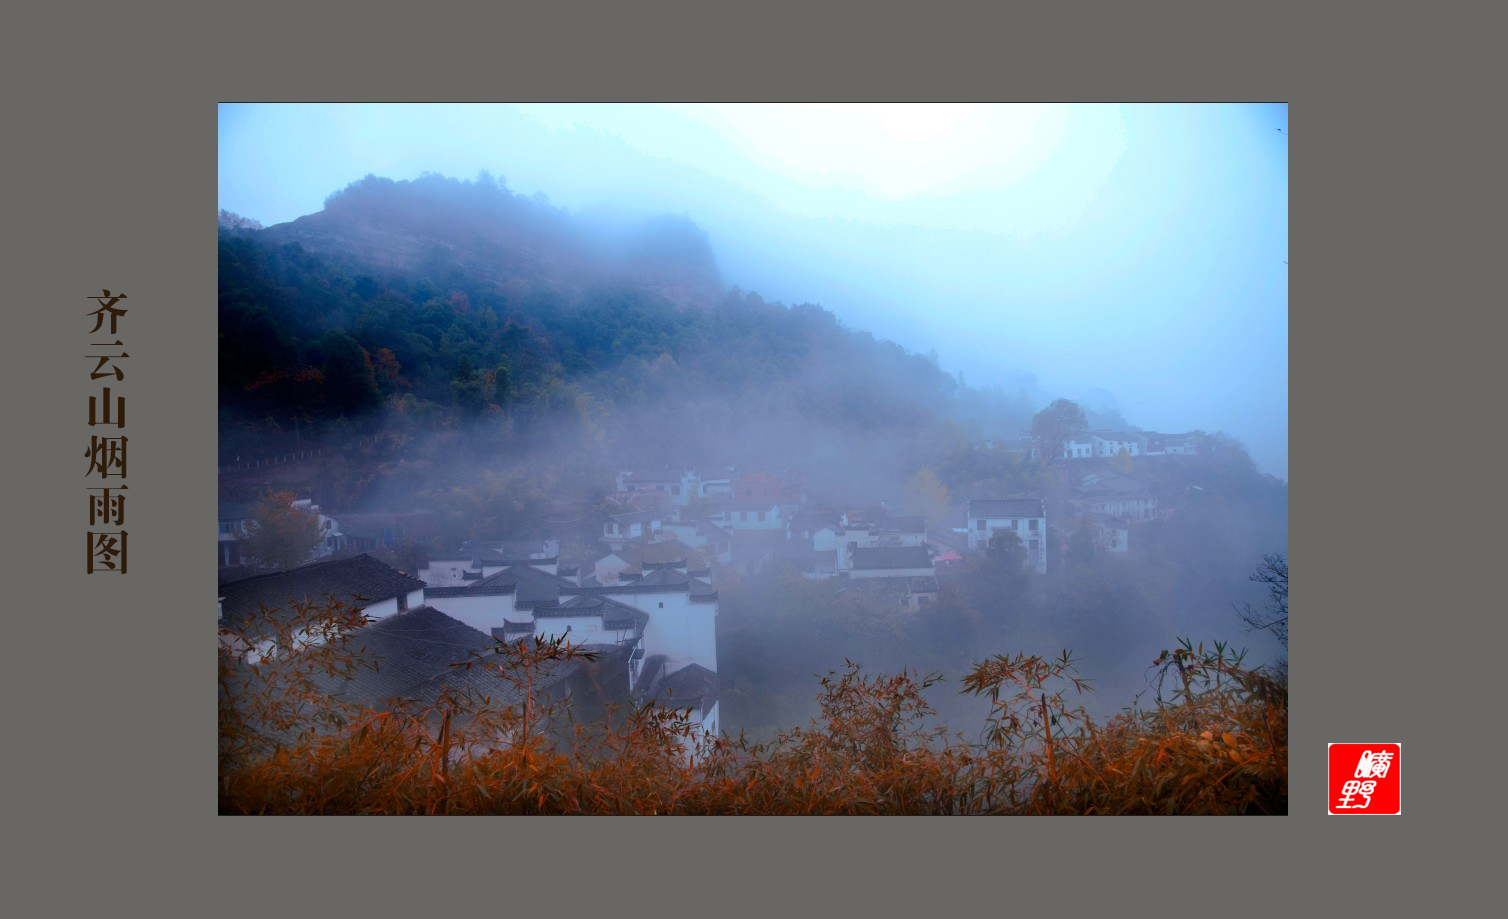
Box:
(217, 106), (1288, 815)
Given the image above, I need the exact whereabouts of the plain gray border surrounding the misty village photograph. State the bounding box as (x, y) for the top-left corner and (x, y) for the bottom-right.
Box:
(6, 3), (1477, 913)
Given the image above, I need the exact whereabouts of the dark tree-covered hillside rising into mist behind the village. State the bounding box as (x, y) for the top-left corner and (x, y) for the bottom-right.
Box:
(220, 177), (1031, 516)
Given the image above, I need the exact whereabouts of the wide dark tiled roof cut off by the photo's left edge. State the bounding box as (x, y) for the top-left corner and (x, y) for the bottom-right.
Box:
(220, 554), (424, 628)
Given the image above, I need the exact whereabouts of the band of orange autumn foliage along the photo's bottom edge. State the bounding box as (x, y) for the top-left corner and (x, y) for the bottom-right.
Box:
(219, 604), (1288, 815)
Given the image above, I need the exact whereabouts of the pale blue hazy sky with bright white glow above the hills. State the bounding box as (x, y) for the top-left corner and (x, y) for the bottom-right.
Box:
(219, 104), (1288, 478)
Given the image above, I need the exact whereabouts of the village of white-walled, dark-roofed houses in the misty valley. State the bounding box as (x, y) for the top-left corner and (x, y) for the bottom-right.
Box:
(219, 432), (1199, 736)
